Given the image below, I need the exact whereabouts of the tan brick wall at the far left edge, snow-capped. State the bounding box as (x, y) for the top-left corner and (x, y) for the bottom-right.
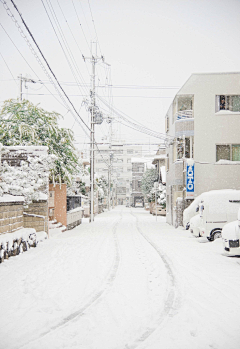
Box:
(0, 202), (23, 234)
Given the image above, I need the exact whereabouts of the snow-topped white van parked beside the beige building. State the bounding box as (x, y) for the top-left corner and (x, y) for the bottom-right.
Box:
(199, 189), (240, 241)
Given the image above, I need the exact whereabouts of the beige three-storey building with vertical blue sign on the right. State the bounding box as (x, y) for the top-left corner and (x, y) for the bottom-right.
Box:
(165, 73), (240, 226)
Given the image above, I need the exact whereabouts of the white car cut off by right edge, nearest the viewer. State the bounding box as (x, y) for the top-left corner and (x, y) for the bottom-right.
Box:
(222, 209), (240, 256)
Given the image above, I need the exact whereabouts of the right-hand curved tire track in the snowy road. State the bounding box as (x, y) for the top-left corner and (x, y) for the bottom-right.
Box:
(124, 212), (177, 349)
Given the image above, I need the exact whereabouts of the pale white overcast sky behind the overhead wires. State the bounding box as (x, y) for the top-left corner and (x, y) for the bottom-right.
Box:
(0, 0), (240, 152)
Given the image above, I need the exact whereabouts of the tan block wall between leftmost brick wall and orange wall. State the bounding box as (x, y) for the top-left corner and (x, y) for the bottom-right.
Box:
(23, 200), (48, 232)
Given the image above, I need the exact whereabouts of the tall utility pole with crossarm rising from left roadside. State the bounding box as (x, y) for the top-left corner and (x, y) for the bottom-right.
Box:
(82, 42), (109, 222)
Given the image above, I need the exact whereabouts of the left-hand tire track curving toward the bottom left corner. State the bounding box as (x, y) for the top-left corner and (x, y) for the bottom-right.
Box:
(18, 211), (122, 349)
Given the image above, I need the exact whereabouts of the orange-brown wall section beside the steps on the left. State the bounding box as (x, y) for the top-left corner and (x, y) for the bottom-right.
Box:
(49, 184), (67, 226)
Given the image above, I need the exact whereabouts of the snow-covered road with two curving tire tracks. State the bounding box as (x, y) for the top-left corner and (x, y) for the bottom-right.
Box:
(0, 206), (240, 349)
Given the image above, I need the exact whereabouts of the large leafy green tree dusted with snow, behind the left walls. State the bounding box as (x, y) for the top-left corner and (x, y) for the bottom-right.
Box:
(0, 99), (78, 183)
